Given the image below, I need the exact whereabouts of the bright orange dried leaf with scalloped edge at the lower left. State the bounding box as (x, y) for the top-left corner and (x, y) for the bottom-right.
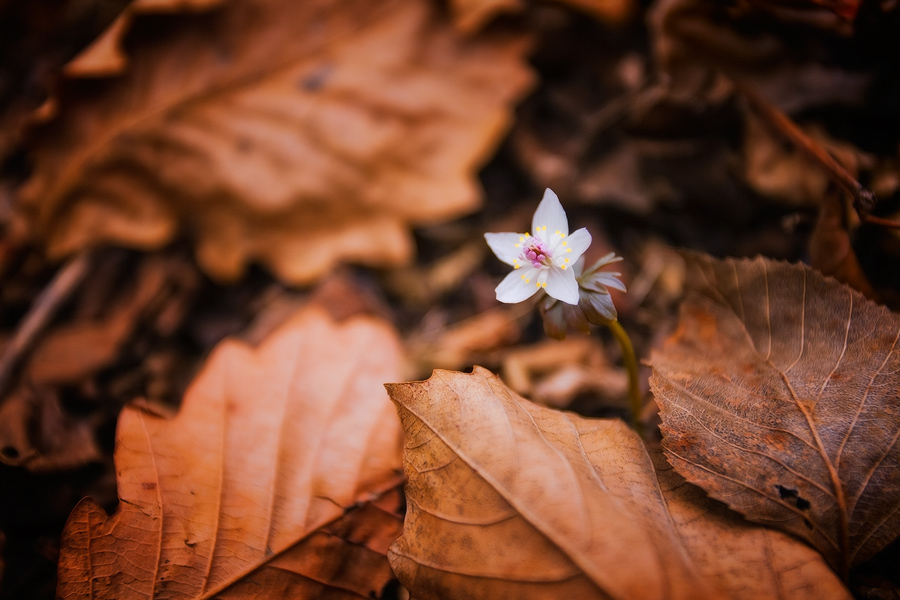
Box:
(57, 309), (401, 600)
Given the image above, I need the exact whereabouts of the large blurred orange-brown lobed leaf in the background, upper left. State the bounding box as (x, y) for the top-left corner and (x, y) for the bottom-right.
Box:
(18, 0), (532, 283)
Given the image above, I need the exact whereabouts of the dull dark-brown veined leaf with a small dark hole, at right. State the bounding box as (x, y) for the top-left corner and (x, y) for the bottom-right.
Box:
(650, 255), (900, 574)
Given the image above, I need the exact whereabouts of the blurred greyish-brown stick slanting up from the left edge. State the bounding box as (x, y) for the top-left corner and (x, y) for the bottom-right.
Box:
(0, 251), (91, 397)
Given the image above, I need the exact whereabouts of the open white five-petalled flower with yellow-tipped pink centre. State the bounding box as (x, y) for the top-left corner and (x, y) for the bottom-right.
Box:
(484, 188), (591, 304)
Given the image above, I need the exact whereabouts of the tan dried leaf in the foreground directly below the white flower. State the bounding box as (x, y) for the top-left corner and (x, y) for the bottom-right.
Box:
(387, 367), (849, 599)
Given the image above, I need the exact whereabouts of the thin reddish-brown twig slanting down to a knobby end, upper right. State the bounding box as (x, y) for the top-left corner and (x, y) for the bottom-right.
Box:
(733, 82), (878, 218)
